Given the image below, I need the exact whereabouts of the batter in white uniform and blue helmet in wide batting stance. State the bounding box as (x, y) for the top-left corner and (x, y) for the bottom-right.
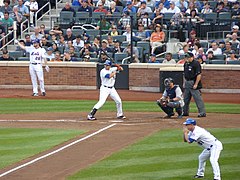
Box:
(87, 60), (126, 120)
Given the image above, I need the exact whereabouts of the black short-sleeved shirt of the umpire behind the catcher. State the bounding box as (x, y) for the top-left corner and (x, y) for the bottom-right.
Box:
(184, 60), (201, 81)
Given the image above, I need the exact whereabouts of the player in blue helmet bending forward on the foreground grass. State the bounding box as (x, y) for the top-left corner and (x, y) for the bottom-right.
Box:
(183, 118), (223, 180)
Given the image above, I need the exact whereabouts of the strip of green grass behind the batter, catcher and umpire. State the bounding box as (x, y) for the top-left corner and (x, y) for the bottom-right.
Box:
(0, 98), (240, 114)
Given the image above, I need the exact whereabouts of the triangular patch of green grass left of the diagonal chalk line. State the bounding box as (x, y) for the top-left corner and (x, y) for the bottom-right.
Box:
(0, 128), (84, 168)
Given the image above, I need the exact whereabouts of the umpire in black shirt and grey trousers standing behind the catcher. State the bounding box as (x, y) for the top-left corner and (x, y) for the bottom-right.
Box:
(183, 52), (206, 117)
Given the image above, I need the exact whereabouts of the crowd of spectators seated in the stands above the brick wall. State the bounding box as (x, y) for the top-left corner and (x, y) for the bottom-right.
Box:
(0, 0), (240, 64)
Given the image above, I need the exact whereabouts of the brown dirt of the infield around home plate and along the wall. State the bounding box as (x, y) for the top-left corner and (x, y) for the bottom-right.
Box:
(0, 90), (240, 180)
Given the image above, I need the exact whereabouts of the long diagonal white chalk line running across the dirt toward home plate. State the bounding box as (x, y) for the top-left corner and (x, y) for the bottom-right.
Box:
(0, 123), (116, 177)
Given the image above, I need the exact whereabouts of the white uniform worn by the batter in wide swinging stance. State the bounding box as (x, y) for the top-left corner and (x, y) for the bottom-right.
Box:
(93, 67), (123, 117)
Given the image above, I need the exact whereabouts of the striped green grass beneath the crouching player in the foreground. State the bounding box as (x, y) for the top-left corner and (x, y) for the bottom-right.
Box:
(68, 129), (240, 180)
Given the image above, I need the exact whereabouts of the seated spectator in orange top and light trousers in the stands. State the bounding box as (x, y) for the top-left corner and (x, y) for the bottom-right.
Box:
(150, 24), (165, 54)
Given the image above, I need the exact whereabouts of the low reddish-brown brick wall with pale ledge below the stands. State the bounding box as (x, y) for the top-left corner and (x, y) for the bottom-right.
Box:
(0, 62), (240, 93)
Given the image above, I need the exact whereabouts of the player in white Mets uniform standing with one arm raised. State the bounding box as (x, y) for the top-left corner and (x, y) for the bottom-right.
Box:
(16, 39), (49, 96)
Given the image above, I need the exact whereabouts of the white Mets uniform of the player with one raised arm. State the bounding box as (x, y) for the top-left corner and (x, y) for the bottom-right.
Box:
(25, 46), (46, 94)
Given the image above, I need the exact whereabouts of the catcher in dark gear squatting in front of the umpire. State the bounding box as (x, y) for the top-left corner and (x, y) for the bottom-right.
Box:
(157, 77), (184, 118)
